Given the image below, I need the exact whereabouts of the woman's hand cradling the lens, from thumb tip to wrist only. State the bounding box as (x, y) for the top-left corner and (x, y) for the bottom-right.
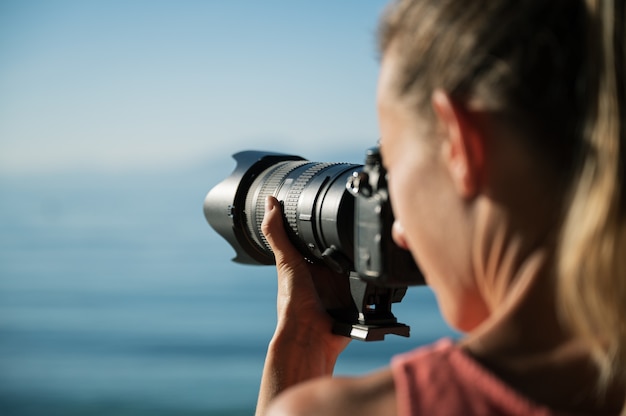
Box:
(262, 197), (352, 359)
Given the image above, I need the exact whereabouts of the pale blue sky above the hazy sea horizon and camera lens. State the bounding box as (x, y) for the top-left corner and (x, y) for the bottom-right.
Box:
(0, 0), (386, 174)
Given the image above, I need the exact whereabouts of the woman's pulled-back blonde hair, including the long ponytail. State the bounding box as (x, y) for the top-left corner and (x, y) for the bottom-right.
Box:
(380, 0), (626, 394)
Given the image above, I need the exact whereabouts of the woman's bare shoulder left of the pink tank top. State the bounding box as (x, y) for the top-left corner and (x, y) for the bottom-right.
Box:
(269, 369), (396, 416)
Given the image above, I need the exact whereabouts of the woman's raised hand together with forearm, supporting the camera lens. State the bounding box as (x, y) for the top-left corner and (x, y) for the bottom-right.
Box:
(256, 197), (352, 416)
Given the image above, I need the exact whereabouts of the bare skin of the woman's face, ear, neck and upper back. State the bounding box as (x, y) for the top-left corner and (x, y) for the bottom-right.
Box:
(378, 53), (623, 411)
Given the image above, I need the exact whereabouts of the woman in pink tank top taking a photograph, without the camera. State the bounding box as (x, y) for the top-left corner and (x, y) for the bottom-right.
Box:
(257, 0), (626, 415)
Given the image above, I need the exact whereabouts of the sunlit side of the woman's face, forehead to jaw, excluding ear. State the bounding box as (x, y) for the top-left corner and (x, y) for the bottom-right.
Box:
(378, 57), (488, 330)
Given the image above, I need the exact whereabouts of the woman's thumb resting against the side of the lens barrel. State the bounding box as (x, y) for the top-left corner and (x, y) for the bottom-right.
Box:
(261, 196), (303, 267)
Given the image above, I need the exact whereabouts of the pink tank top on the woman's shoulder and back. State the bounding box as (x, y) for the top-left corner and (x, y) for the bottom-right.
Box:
(391, 339), (572, 416)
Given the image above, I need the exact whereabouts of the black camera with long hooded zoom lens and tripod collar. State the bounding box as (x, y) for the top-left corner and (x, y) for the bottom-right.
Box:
(204, 147), (424, 341)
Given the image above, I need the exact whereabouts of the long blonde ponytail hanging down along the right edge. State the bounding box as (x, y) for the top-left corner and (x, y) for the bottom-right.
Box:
(558, 0), (626, 387)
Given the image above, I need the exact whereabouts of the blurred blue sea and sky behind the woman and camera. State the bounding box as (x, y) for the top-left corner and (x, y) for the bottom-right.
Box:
(0, 0), (453, 415)
